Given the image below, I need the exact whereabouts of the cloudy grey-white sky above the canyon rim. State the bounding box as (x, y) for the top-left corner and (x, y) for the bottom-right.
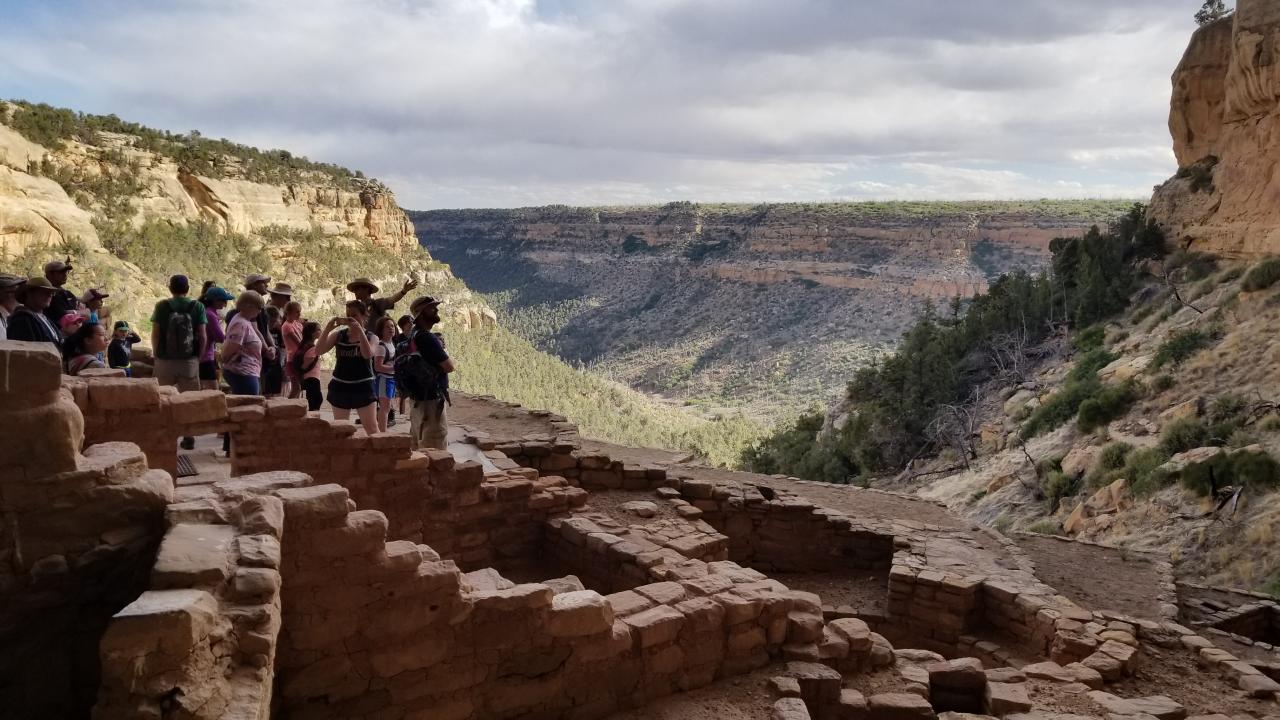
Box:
(0, 0), (1199, 209)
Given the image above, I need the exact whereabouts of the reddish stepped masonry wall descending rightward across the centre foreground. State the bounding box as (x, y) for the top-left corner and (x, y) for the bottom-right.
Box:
(278, 476), (870, 720)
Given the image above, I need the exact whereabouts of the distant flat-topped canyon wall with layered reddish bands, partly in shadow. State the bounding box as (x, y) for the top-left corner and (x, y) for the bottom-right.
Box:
(410, 201), (1129, 419)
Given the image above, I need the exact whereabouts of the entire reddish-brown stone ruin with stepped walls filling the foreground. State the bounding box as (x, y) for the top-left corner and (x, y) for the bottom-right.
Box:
(0, 342), (1280, 720)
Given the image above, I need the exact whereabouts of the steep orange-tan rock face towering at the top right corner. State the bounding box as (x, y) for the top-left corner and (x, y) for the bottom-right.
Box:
(1151, 0), (1280, 258)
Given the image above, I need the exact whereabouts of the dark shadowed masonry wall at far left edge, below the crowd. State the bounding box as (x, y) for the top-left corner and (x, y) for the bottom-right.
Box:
(0, 341), (173, 717)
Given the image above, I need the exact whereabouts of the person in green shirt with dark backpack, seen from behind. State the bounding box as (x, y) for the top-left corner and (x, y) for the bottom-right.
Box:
(151, 275), (209, 450)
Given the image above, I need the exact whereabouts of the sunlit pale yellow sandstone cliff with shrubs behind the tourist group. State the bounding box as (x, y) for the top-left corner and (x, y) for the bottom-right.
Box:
(0, 102), (494, 328)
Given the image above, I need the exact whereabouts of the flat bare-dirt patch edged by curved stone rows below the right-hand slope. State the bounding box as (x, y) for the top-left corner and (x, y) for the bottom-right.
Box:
(1015, 534), (1165, 618)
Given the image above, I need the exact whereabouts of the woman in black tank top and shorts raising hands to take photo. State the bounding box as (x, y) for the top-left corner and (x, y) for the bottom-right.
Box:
(316, 300), (378, 434)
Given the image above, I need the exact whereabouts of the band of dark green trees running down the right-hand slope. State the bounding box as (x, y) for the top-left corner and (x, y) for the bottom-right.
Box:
(744, 205), (1162, 482)
